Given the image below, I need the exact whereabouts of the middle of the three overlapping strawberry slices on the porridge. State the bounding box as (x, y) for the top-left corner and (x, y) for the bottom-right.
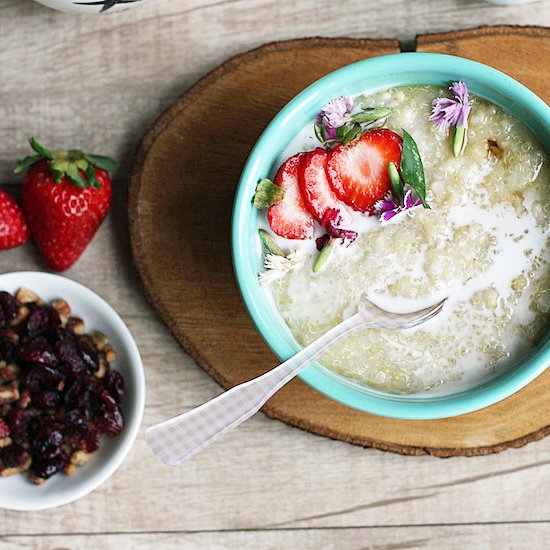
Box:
(298, 147), (351, 225)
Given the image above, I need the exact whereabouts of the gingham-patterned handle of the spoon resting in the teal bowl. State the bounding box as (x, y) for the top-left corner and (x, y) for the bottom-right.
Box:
(145, 313), (374, 466)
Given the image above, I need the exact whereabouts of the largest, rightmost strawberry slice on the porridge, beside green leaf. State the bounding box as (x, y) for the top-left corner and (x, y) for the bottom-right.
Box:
(326, 128), (402, 213)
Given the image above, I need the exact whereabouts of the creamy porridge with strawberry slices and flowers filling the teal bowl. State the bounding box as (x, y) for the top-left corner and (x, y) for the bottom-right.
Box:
(255, 83), (550, 393)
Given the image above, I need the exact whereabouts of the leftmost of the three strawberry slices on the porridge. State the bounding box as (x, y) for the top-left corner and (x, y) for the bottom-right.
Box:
(267, 153), (315, 239)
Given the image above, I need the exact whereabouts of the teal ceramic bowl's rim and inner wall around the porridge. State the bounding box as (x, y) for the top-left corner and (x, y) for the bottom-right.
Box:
(232, 53), (550, 420)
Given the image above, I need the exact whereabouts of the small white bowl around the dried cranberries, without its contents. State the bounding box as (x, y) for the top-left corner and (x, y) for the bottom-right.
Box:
(0, 271), (145, 510)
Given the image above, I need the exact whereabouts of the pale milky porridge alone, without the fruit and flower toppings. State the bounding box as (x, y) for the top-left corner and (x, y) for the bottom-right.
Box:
(271, 86), (550, 393)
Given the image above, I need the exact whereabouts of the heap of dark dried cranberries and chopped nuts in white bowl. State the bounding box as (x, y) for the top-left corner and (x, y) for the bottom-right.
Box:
(0, 292), (125, 481)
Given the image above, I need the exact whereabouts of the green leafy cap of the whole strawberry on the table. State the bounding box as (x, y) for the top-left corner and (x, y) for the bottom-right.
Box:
(15, 137), (117, 189)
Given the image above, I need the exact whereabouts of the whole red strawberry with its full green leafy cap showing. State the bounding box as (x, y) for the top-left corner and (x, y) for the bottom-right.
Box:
(15, 138), (116, 271)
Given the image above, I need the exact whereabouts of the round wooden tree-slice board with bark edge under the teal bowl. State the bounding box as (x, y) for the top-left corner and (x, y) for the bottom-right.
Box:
(129, 27), (550, 457)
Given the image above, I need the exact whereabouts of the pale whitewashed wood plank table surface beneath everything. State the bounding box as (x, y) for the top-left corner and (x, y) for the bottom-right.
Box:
(0, 0), (550, 550)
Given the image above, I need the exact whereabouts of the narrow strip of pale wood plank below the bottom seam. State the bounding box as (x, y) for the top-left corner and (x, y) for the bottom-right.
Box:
(0, 523), (550, 550)
